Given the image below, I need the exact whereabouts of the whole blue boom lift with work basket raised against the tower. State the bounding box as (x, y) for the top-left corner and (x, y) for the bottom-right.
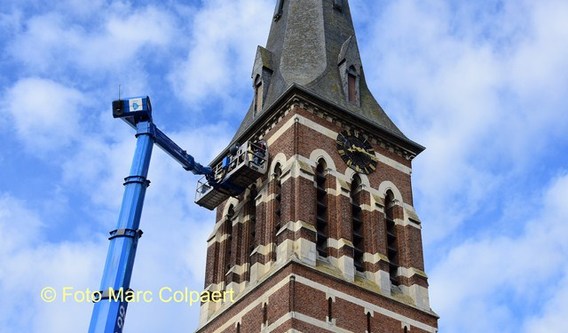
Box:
(89, 96), (268, 333)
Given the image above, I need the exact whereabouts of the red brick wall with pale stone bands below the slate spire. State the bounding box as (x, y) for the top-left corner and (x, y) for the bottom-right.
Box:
(199, 94), (437, 333)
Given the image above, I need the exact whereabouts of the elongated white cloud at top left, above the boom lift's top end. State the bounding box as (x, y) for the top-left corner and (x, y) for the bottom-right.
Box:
(9, 3), (177, 74)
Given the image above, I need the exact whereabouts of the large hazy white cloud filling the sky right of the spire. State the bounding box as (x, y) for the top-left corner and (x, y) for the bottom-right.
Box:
(355, 0), (568, 244)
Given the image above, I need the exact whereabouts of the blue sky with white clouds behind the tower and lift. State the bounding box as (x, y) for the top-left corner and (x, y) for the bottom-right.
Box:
(0, 0), (568, 333)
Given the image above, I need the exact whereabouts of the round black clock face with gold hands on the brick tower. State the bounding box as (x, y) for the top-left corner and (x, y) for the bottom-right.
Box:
(337, 130), (377, 175)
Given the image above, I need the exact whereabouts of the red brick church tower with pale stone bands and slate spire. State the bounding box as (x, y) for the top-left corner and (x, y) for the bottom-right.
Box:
(197, 0), (438, 333)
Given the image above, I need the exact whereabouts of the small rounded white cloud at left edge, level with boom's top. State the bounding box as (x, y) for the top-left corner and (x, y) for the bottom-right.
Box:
(2, 78), (84, 153)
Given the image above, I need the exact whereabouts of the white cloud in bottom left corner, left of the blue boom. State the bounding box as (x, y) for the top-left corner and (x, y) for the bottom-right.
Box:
(0, 194), (106, 332)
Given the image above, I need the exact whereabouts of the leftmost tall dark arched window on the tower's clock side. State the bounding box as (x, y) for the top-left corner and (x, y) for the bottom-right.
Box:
(315, 159), (329, 257)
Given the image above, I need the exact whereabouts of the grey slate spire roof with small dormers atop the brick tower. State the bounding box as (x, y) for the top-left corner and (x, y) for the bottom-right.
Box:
(234, 0), (418, 148)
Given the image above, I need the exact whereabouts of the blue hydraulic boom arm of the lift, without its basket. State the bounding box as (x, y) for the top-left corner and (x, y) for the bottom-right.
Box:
(89, 97), (213, 333)
